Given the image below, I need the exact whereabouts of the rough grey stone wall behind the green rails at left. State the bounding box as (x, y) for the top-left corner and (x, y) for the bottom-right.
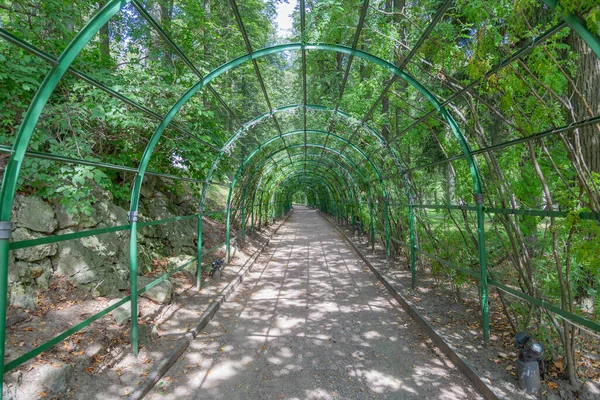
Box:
(8, 179), (223, 309)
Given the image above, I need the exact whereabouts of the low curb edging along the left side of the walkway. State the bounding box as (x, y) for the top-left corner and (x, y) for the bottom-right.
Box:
(127, 212), (292, 400)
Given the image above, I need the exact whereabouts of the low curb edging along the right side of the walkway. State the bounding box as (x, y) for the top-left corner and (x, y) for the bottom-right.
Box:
(319, 212), (501, 400)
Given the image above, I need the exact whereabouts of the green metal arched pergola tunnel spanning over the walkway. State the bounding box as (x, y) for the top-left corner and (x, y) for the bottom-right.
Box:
(0, 0), (600, 394)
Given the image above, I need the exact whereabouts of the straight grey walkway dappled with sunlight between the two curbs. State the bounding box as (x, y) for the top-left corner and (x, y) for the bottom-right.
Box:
(147, 206), (480, 400)
